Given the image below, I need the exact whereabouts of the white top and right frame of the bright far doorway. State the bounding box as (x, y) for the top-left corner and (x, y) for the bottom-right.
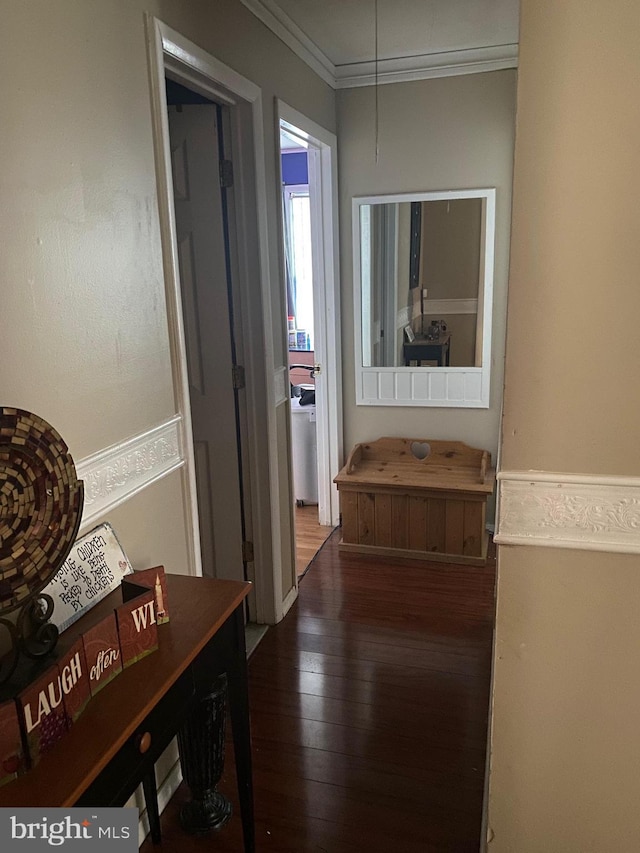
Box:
(276, 99), (343, 527)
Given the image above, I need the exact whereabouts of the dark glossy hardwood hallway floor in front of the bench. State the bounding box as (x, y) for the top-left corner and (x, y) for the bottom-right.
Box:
(142, 530), (495, 853)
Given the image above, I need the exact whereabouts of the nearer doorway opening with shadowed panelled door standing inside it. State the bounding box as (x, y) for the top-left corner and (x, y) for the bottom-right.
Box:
(165, 77), (249, 580)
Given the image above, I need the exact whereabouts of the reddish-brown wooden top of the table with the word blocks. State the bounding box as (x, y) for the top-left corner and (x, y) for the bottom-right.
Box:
(0, 574), (251, 807)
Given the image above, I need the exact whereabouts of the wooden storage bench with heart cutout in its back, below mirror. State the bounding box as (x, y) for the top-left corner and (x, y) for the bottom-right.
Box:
(335, 438), (495, 565)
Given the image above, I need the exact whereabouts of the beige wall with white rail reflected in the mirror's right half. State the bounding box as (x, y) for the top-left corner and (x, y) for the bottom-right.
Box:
(420, 198), (482, 367)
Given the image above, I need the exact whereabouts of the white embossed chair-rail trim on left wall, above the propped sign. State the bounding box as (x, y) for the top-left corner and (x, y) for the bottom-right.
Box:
(76, 415), (185, 533)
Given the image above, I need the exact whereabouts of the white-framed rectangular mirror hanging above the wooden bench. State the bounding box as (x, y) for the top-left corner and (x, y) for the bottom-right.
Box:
(353, 189), (495, 408)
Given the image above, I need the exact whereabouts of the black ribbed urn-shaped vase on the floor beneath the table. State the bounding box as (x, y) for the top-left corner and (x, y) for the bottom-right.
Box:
(178, 675), (232, 835)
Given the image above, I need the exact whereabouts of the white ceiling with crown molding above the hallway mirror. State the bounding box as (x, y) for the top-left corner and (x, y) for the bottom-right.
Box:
(242, 0), (519, 88)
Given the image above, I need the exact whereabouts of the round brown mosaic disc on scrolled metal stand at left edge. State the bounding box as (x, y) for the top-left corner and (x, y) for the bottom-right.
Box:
(0, 406), (83, 613)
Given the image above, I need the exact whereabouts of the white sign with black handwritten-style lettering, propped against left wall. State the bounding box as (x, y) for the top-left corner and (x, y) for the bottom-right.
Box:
(44, 524), (133, 631)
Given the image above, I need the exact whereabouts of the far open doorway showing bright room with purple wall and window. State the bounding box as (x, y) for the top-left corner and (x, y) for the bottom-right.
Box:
(279, 104), (341, 576)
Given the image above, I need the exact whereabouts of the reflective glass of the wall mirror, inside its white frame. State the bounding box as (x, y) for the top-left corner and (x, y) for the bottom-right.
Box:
(359, 192), (487, 368)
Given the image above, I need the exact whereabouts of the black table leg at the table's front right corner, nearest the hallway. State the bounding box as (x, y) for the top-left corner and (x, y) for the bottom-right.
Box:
(227, 607), (255, 853)
